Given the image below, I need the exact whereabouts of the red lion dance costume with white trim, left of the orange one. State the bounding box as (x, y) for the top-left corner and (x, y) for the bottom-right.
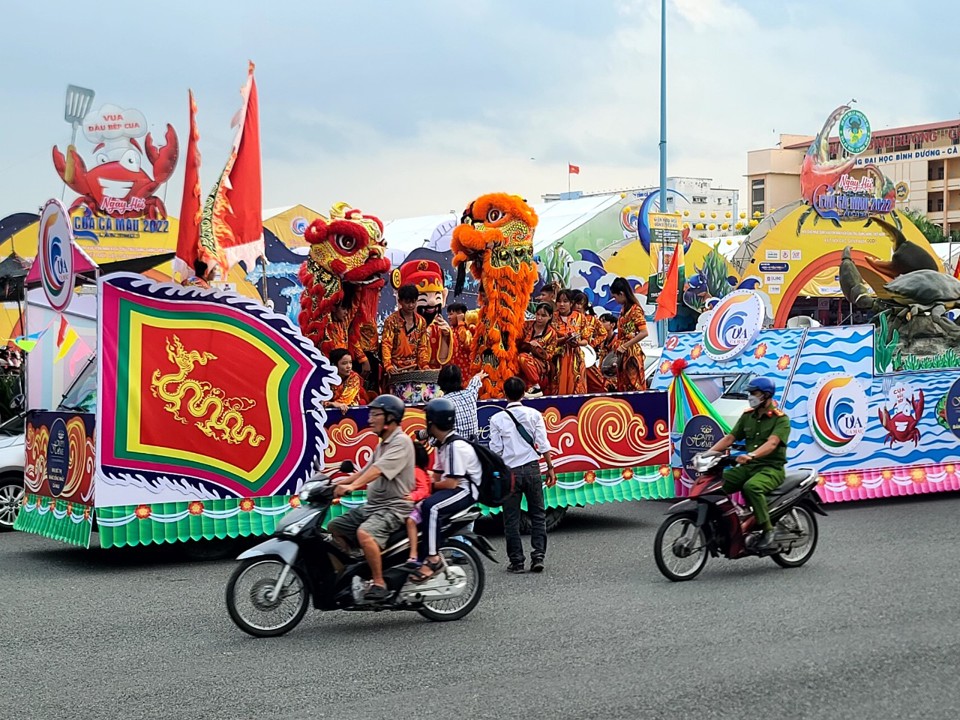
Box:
(298, 202), (390, 374)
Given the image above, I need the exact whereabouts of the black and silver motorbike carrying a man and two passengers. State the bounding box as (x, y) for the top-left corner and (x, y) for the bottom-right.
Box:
(226, 461), (497, 637)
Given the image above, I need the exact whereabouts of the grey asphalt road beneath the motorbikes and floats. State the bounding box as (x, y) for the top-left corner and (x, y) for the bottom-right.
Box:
(0, 495), (960, 720)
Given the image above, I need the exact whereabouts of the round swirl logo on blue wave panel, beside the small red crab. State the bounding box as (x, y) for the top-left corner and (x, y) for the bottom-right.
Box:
(807, 374), (867, 455)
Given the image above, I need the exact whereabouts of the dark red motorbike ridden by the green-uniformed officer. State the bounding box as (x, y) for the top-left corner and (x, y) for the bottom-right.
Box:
(654, 452), (826, 582)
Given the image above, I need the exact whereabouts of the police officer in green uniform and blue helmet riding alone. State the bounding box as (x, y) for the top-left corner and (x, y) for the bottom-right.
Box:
(710, 377), (790, 550)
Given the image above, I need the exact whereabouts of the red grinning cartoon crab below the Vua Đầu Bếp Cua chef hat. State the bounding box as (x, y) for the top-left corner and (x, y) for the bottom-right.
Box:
(53, 124), (180, 220)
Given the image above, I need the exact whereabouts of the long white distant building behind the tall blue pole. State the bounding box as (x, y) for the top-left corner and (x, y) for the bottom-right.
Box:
(542, 174), (740, 231)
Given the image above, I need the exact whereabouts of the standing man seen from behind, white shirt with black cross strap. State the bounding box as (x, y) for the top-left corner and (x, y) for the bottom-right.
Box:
(490, 376), (557, 573)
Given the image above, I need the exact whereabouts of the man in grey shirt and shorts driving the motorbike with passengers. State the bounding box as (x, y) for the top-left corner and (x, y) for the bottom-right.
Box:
(327, 395), (416, 600)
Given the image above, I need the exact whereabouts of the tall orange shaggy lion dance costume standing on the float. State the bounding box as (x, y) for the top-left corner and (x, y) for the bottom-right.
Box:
(450, 193), (537, 398)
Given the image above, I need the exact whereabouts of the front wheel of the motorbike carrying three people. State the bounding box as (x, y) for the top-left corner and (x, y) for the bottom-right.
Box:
(227, 557), (310, 637)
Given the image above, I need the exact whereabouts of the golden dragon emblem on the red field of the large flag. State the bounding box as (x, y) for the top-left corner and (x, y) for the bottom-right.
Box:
(150, 335), (264, 447)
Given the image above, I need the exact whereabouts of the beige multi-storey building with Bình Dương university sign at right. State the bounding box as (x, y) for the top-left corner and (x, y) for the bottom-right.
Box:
(746, 120), (960, 234)
